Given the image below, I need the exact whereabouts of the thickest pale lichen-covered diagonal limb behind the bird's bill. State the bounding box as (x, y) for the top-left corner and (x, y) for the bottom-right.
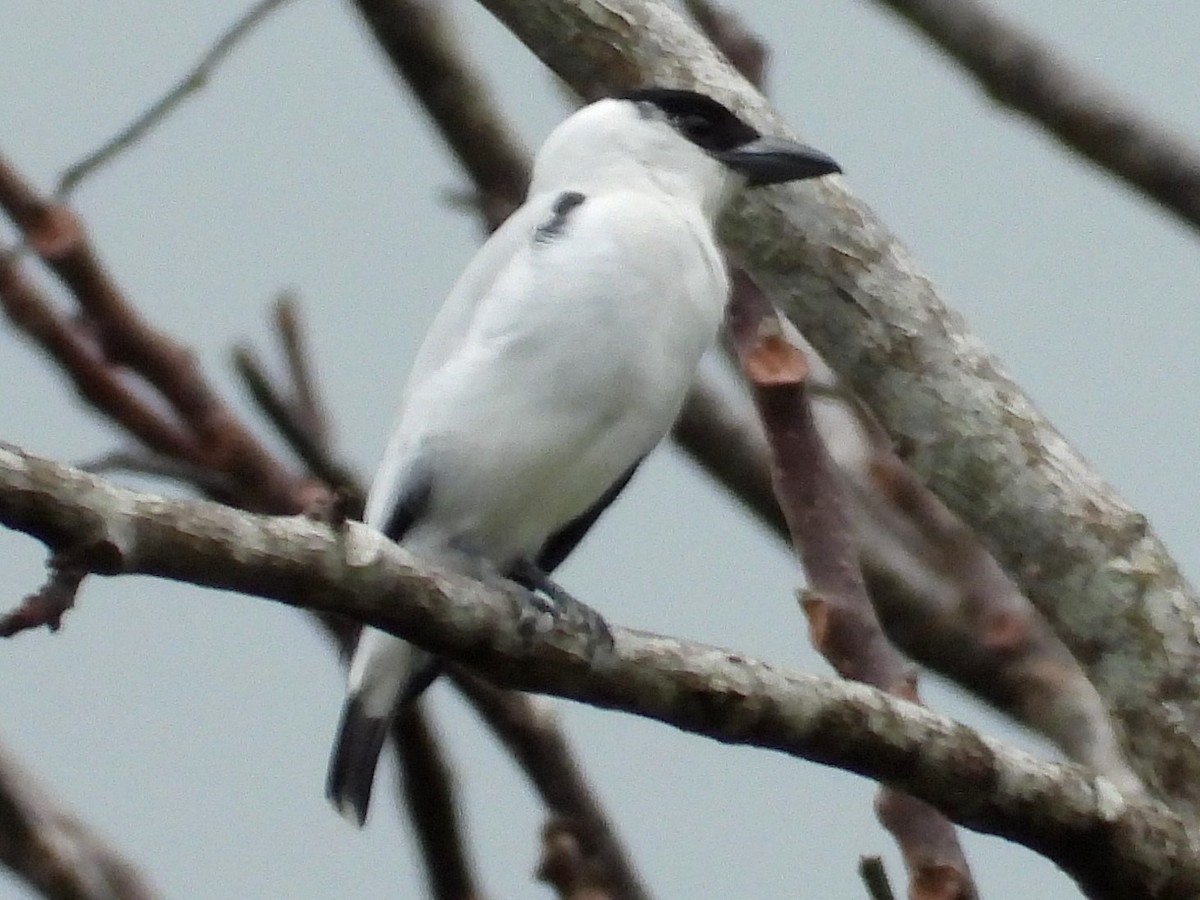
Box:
(472, 0), (1200, 816)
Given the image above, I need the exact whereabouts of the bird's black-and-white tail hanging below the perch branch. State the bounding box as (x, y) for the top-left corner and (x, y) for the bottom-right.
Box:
(325, 629), (439, 828)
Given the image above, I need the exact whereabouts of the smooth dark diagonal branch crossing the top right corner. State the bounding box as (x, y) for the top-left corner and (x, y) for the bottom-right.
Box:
(875, 0), (1200, 236)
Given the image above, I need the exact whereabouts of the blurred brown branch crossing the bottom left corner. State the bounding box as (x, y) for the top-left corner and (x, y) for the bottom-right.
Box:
(0, 746), (158, 900)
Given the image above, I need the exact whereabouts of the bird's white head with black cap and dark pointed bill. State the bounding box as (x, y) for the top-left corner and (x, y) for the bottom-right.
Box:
(534, 88), (841, 212)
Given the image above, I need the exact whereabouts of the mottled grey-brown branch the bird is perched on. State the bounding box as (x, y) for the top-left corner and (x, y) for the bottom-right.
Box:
(0, 445), (1200, 900)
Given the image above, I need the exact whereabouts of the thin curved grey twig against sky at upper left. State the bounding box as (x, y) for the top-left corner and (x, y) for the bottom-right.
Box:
(54, 0), (300, 200)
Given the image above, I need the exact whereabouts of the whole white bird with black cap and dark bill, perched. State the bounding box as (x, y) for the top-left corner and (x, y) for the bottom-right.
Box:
(326, 86), (841, 827)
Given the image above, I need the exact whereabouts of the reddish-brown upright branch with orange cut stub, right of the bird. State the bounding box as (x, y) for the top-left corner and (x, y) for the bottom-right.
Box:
(728, 270), (976, 900)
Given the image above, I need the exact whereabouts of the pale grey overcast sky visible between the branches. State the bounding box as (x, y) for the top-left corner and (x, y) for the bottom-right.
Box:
(0, 0), (1200, 900)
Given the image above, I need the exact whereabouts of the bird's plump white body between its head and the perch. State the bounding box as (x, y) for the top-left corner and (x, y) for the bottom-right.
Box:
(368, 191), (726, 564)
